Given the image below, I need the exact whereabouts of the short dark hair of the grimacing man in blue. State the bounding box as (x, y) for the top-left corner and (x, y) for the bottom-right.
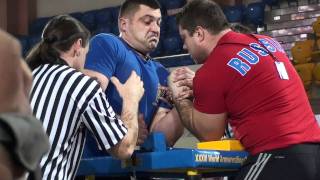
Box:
(119, 0), (160, 17)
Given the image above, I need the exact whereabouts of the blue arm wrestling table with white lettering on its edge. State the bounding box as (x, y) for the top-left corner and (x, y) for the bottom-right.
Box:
(77, 133), (248, 179)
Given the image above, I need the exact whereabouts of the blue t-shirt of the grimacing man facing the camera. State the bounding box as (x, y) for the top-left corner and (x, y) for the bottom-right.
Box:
(85, 34), (171, 126)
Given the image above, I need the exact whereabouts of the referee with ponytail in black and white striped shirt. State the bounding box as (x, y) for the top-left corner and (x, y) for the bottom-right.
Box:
(27, 15), (144, 180)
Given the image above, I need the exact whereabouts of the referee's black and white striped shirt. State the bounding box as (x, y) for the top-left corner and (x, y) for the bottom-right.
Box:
(31, 64), (127, 180)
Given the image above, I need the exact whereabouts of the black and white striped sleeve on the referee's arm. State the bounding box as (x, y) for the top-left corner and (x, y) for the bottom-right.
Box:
(83, 88), (127, 151)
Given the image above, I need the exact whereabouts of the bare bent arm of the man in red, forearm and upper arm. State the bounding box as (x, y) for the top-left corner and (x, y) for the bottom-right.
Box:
(175, 99), (227, 141)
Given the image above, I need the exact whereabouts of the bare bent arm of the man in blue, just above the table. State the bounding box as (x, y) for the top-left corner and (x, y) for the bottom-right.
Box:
(150, 107), (184, 146)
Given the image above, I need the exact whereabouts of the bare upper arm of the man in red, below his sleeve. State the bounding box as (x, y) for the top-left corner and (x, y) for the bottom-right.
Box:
(192, 108), (227, 141)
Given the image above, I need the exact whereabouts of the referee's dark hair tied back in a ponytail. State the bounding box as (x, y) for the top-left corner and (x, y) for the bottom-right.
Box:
(26, 15), (90, 70)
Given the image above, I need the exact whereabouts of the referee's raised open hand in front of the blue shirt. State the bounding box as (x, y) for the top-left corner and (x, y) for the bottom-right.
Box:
(110, 71), (144, 102)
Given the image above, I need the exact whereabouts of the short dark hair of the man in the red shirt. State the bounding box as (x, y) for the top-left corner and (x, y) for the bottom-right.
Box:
(176, 0), (230, 34)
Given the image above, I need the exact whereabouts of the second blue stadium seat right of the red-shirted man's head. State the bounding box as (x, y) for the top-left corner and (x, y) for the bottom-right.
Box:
(245, 2), (265, 26)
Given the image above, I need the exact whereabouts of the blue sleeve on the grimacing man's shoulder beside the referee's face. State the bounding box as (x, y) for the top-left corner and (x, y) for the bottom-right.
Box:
(84, 34), (121, 78)
